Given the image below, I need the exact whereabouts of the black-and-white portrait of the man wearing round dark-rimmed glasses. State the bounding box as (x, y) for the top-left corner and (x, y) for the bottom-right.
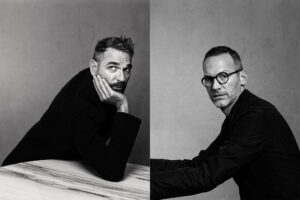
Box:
(150, 0), (300, 200)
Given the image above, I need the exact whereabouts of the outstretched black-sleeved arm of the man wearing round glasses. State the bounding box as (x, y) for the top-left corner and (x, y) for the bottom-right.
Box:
(151, 110), (270, 199)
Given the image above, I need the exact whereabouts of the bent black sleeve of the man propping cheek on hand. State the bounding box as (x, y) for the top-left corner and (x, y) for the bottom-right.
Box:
(70, 113), (140, 181)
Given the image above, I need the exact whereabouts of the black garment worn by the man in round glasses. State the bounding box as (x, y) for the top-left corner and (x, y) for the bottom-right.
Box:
(150, 90), (300, 200)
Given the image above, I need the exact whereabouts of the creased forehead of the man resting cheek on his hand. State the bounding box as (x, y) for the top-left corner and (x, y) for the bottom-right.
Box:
(100, 48), (131, 63)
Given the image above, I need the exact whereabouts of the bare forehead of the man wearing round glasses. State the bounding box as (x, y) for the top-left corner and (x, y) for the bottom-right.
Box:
(203, 53), (236, 76)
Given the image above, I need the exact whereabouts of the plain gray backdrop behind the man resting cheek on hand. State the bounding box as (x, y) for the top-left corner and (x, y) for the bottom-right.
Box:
(0, 0), (150, 164)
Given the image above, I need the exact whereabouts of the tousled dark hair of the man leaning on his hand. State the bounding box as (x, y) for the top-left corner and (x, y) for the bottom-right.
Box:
(93, 36), (134, 61)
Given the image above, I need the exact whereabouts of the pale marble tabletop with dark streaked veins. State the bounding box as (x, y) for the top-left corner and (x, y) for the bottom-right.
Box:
(0, 160), (150, 200)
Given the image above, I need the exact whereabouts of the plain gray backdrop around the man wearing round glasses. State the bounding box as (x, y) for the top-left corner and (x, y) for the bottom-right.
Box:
(150, 0), (300, 200)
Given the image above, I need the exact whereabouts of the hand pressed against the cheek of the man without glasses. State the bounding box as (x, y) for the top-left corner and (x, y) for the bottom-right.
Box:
(93, 75), (129, 113)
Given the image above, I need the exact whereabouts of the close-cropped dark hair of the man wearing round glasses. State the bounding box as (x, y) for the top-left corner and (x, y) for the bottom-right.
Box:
(203, 46), (243, 69)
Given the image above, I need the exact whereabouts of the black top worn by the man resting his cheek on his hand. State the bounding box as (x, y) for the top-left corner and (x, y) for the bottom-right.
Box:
(3, 69), (140, 181)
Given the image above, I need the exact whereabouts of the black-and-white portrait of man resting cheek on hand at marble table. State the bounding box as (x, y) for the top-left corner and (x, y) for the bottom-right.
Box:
(0, 0), (150, 200)
